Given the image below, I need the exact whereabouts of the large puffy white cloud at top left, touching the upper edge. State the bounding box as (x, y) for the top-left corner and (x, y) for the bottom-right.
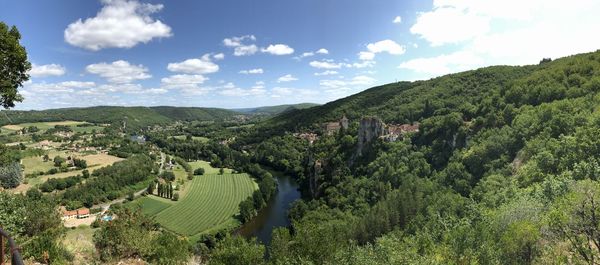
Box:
(64, 0), (172, 51)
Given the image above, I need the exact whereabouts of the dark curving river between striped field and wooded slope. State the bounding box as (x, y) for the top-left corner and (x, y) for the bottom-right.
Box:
(237, 172), (300, 245)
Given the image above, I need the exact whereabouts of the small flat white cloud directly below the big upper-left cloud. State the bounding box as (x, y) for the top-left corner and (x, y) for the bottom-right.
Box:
(85, 60), (152, 84)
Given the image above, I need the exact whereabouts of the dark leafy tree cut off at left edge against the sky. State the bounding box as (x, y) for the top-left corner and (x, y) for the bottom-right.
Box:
(0, 22), (31, 108)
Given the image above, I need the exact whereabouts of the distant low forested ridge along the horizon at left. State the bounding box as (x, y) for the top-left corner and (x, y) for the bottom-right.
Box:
(0, 106), (240, 128)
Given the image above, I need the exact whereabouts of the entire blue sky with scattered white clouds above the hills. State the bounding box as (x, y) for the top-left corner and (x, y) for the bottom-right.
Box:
(0, 0), (600, 110)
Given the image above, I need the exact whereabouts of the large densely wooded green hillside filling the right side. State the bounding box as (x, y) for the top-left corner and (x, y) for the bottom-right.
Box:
(215, 51), (600, 264)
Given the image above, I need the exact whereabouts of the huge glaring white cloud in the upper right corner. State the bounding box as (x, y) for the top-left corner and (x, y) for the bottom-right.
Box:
(400, 0), (600, 78)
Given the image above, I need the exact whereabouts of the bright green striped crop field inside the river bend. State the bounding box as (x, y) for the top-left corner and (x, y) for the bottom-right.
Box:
(156, 174), (257, 236)
